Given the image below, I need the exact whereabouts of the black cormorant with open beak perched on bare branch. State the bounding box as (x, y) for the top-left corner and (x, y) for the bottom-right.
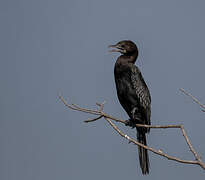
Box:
(109, 40), (151, 174)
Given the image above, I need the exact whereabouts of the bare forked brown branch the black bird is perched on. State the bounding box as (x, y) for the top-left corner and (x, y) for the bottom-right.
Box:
(59, 95), (205, 170)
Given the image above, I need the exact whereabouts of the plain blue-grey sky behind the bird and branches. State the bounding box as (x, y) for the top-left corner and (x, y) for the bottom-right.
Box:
(0, 0), (205, 180)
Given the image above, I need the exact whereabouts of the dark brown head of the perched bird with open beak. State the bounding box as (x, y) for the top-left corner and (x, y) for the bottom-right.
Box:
(108, 40), (138, 55)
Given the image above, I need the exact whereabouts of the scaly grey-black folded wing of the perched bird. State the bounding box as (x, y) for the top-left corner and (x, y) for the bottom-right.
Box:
(131, 64), (151, 125)
